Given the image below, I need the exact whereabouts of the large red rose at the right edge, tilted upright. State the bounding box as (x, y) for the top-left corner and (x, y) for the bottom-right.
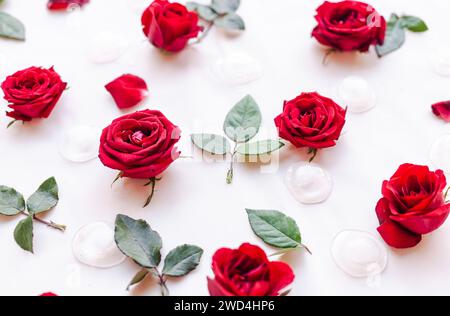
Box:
(376, 164), (450, 248)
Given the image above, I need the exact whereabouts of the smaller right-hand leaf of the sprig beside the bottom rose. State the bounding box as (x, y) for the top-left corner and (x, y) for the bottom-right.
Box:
(162, 245), (203, 277)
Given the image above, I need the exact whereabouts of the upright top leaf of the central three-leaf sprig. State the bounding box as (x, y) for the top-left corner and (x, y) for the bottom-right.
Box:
(223, 95), (262, 143)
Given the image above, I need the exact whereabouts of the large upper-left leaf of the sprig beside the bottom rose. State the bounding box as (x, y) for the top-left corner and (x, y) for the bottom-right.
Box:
(114, 215), (162, 269)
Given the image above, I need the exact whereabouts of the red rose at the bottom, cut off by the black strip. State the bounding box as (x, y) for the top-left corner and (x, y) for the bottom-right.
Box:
(208, 244), (295, 296)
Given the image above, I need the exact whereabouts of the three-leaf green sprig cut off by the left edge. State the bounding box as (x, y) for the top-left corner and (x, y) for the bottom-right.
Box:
(0, 177), (66, 253)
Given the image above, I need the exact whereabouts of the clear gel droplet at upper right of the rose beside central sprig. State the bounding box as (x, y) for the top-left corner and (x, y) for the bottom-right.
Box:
(338, 76), (376, 113)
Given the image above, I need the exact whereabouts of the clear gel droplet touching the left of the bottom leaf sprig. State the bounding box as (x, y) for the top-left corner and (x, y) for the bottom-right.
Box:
(72, 222), (125, 269)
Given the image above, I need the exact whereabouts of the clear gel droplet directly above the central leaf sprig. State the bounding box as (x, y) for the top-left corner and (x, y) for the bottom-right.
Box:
(211, 53), (264, 85)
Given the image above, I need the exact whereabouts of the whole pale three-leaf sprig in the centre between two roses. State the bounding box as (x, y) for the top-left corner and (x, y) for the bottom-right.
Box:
(191, 95), (284, 184)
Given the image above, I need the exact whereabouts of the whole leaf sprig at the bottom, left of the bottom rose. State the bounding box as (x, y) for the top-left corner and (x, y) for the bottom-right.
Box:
(114, 215), (203, 296)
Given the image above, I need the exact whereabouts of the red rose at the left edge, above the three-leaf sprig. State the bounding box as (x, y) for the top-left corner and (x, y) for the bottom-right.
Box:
(2, 67), (67, 121)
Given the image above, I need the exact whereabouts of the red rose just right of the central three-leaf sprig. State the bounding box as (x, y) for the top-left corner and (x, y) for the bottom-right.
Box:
(275, 92), (346, 149)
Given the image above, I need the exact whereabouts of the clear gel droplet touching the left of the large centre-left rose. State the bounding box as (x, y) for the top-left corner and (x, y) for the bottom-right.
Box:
(59, 126), (101, 163)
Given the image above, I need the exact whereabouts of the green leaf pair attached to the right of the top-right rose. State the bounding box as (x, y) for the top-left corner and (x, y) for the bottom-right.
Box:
(375, 14), (428, 58)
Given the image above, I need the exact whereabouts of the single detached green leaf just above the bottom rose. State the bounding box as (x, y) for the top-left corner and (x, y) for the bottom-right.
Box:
(247, 209), (302, 249)
